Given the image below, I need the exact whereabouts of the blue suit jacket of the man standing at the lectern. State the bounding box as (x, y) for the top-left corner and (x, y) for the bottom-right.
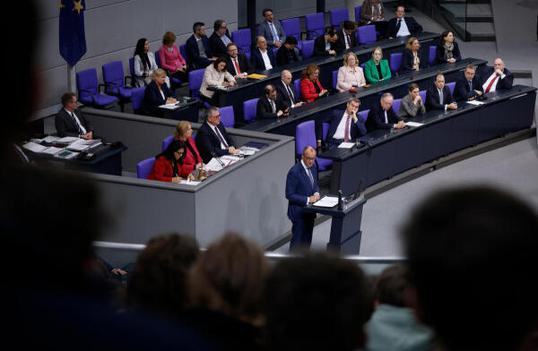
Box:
(286, 161), (319, 221)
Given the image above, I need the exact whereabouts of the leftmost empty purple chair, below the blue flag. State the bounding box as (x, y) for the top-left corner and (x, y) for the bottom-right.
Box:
(76, 68), (118, 108)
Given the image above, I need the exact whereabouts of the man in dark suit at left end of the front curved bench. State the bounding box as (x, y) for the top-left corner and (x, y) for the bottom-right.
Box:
(327, 98), (366, 145)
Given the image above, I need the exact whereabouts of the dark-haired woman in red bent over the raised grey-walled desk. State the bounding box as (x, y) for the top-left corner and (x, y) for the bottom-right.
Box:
(148, 140), (185, 183)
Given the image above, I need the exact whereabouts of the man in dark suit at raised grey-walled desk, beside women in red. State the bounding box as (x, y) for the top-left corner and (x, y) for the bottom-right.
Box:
(196, 107), (239, 163)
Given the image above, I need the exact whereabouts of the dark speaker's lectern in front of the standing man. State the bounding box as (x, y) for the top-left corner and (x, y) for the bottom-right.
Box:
(304, 195), (366, 255)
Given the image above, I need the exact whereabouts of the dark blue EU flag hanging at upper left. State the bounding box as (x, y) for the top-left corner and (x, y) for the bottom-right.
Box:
(59, 0), (86, 66)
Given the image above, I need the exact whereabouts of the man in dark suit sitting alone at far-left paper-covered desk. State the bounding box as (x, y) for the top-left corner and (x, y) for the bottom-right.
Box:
(54, 93), (93, 140)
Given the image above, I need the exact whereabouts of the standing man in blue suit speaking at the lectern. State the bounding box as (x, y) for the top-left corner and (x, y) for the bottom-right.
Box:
(286, 146), (320, 251)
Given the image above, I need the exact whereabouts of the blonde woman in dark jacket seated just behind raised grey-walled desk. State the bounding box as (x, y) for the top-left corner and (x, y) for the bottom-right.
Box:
(142, 68), (177, 117)
